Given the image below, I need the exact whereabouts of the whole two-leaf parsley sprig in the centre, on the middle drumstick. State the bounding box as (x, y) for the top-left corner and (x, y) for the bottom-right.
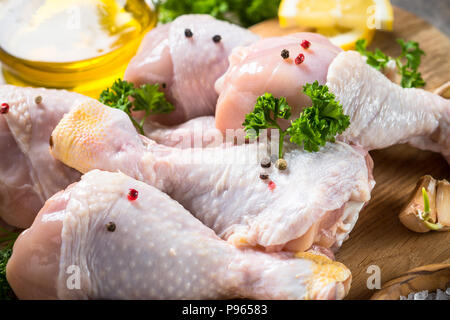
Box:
(242, 81), (350, 159)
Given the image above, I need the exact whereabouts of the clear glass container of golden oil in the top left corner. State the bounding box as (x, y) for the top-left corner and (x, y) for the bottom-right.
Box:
(0, 0), (156, 98)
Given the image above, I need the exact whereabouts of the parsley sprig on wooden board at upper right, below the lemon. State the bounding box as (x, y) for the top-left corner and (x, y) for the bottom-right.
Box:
(356, 39), (426, 88)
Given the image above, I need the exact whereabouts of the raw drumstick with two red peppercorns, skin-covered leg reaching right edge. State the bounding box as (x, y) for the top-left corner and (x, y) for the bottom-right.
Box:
(216, 33), (450, 162)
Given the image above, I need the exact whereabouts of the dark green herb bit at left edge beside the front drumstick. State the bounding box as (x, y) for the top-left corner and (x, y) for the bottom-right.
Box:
(0, 228), (19, 300)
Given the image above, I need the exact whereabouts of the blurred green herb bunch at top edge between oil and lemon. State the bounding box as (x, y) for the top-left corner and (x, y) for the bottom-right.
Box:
(153, 0), (281, 27)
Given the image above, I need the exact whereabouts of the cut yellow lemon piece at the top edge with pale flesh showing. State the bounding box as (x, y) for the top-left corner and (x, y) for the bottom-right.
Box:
(278, 0), (394, 31)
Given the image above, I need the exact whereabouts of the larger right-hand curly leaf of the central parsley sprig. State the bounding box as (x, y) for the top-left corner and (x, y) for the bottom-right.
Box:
(287, 81), (350, 152)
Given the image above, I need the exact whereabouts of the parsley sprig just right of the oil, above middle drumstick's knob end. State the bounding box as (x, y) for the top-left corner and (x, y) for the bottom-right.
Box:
(99, 79), (175, 134)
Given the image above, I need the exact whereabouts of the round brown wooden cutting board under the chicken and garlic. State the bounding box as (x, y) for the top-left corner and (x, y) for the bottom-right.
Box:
(251, 8), (450, 299)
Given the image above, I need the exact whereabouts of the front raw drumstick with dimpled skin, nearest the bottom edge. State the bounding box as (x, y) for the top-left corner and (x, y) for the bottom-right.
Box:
(7, 170), (351, 299)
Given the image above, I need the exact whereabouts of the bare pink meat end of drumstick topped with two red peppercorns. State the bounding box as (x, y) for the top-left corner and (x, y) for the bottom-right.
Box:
(215, 33), (342, 132)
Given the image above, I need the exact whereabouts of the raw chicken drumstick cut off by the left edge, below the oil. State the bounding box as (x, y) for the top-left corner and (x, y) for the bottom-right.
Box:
(0, 85), (89, 228)
